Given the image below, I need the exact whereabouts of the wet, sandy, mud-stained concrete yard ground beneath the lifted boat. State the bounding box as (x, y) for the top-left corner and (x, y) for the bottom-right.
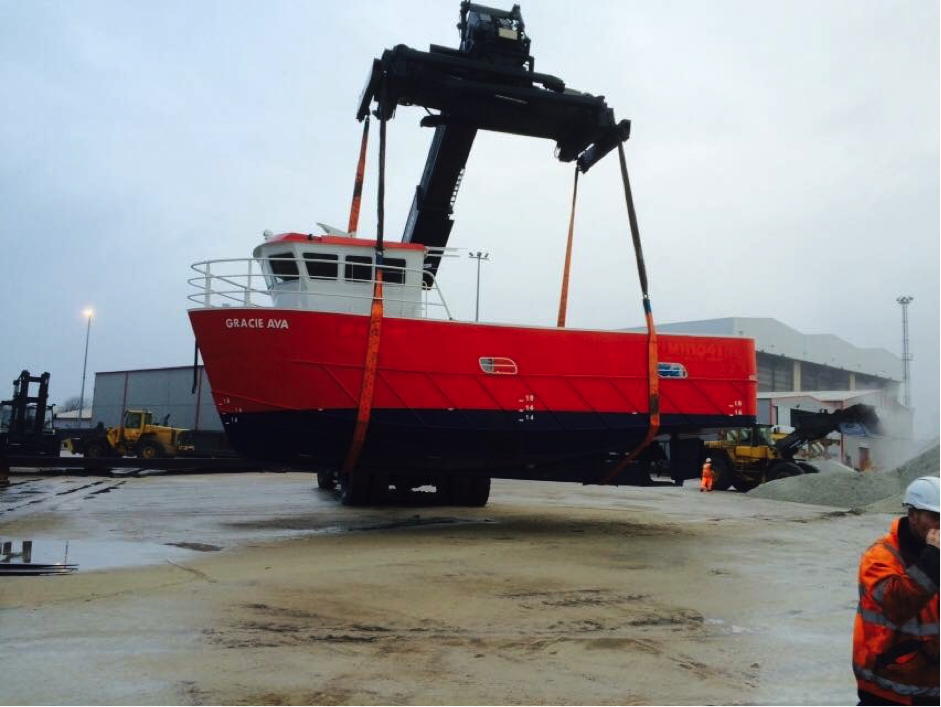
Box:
(0, 473), (890, 705)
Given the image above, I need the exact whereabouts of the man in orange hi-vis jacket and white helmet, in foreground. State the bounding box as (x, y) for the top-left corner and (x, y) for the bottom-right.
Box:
(853, 476), (941, 707)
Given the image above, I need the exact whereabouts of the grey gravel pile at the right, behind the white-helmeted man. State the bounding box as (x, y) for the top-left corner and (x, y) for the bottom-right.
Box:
(748, 445), (941, 513)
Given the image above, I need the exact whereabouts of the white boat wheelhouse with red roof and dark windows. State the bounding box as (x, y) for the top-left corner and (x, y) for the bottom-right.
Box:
(252, 233), (425, 317)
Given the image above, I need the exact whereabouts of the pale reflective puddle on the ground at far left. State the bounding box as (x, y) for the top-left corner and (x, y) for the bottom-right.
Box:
(0, 538), (209, 572)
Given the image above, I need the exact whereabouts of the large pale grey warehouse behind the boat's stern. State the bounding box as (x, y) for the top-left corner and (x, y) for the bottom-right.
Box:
(631, 317), (913, 469)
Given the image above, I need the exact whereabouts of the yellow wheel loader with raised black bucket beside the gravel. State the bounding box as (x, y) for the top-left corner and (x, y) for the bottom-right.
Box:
(703, 404), (881, 491)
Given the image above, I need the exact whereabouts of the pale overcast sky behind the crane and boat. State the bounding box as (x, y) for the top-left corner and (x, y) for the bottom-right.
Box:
(0, 0), (941, 436)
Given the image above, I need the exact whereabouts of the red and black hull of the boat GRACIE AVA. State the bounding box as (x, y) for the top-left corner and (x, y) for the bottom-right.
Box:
(190, 308), (757, 481)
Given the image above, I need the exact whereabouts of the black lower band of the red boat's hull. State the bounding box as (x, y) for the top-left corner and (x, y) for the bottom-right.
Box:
(222, 409), (755, 483)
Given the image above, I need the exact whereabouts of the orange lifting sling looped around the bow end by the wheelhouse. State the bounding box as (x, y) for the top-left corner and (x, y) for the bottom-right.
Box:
(343, 80), (386, 474)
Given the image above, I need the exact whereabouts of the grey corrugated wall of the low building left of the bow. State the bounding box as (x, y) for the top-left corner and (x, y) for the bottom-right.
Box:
(92, 366), (222, 431)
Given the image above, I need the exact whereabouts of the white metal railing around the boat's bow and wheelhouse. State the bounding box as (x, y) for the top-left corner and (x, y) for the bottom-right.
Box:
(187, 257), (454, 319)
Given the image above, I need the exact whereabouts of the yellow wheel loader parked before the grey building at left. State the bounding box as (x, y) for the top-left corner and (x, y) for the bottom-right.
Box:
(66, 410), (186, 459)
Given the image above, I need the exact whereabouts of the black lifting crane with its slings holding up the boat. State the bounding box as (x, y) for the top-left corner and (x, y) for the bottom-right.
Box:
(319, 0), (660, 498)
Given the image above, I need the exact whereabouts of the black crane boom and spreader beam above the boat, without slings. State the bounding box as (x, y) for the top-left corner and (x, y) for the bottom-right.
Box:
(356, 1), (630, 284)
